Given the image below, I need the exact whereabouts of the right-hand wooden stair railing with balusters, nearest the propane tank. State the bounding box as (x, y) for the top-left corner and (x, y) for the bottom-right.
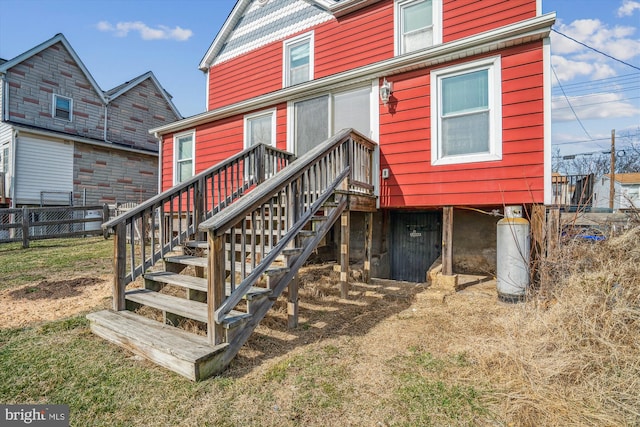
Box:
(199, 129), (377, 345)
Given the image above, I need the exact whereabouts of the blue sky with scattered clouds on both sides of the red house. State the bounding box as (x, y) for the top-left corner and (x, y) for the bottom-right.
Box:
(0, 0), (640, 154)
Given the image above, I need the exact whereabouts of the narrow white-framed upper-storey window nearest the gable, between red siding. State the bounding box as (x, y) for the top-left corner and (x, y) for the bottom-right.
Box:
(283, 33), (313, 87)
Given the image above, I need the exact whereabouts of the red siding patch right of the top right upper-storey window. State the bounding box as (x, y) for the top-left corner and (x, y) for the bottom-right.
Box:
(442, 0), (536, 43)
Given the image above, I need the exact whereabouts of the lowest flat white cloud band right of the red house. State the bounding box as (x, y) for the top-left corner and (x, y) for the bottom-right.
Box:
(551, 93), (640, 122)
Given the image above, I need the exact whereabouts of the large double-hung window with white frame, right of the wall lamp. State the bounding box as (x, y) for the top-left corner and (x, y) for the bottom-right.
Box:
(431, 57), (502, 165)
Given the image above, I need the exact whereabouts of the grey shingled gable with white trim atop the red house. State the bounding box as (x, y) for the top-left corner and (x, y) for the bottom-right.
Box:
(199, 0), (378, 71)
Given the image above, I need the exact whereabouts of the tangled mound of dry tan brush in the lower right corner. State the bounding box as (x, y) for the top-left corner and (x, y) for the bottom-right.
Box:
(478, 227), (640, 425)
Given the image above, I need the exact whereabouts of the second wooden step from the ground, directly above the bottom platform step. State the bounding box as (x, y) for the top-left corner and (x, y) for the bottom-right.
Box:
(125, 289), (251, 326)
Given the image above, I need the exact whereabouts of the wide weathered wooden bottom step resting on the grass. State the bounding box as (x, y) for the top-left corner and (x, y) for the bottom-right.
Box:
(87, 310), (228, 381)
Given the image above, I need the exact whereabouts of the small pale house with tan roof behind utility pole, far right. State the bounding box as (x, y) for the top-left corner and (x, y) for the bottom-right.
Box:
(593, 172), (640, 210)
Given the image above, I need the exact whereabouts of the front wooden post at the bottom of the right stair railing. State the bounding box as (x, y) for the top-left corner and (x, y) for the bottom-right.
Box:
(207, 232), (225, 345)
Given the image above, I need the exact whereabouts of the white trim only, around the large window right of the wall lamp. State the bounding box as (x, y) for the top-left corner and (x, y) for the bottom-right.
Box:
(430, 56), (502, 166)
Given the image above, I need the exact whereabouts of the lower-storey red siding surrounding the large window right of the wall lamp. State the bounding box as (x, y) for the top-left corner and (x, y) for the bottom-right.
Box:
(380, 42), (544, 208)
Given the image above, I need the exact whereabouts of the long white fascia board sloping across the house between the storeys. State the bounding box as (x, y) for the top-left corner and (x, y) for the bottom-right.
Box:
(149, 12), (556, 135)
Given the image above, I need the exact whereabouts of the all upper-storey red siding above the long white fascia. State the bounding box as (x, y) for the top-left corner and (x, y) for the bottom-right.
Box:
(208, 0), (536, 110)
